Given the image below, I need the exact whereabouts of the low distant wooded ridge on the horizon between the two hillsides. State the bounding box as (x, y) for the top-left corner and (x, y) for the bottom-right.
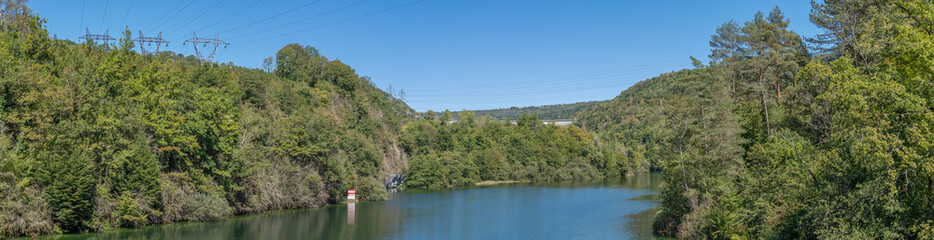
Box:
(454, 101), (605, 120)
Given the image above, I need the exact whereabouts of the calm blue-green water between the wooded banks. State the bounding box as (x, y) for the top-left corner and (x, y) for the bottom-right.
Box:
(38, 174), (661, 240)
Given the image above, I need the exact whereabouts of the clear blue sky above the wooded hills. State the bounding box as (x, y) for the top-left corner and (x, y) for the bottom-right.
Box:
(29, 0), (819, 111)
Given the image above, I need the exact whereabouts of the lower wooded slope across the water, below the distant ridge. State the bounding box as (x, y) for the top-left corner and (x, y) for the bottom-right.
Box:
(403, 111), (634, 188)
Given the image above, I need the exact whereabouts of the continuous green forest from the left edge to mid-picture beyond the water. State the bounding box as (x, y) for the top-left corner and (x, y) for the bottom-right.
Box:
(0, 1), (616, 236)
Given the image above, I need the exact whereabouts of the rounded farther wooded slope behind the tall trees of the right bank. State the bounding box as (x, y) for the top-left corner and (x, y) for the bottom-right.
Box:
(577, 69), (739, 172)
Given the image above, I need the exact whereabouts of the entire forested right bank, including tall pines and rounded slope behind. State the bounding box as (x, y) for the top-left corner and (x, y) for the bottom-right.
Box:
(579, 0), (934, 239)
